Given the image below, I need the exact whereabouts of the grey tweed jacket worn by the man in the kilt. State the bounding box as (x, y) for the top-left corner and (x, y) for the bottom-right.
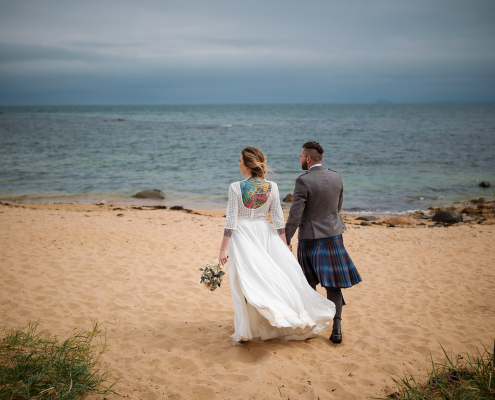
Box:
(285, 166), (346, 244)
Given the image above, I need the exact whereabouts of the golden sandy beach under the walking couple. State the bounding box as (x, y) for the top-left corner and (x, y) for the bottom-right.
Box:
(0, 204), (495, 400)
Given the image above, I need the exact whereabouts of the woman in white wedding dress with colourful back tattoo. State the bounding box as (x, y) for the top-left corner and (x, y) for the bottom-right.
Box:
(218, 147), (335, 341)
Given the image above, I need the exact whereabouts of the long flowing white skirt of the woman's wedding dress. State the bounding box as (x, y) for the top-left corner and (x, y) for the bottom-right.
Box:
(229, 219), (335, 341)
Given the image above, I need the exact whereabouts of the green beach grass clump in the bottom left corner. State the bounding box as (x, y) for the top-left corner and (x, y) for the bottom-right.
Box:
(0, 321), (116, 400)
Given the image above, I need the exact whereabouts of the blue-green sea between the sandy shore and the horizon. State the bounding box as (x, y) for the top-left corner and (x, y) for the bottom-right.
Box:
(0, 104), (495, 214)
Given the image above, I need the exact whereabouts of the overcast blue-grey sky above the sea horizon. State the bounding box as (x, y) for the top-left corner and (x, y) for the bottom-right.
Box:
(0, 0), (495, 105)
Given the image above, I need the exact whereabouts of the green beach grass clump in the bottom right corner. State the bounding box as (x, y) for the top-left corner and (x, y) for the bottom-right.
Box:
(387, 342), (495, 400)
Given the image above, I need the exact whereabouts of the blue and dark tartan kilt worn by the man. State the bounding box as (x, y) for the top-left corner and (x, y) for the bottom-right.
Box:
(297, 235), (362, 288)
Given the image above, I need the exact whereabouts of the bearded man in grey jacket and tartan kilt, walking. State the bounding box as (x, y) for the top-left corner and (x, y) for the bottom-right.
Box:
(285, 142), (361, 343)
